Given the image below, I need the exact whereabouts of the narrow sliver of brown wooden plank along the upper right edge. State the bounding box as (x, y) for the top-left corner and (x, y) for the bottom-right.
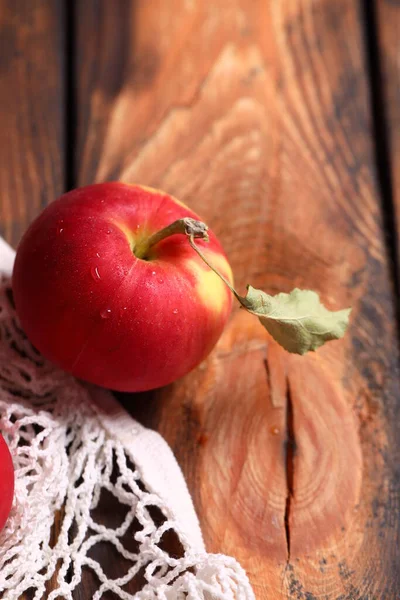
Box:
(375, 0), (400, 264)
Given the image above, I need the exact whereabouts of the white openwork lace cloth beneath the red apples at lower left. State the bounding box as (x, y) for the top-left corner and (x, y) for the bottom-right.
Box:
(0, 238), (254, 600)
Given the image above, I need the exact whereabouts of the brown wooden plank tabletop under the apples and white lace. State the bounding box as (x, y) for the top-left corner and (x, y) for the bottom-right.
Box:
(0, 0), (400, 600)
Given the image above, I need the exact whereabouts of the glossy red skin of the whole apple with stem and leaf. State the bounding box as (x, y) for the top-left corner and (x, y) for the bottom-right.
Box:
(13, 182), (232, 392)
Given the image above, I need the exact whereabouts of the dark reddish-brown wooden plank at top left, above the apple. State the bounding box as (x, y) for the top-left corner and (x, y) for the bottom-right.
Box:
(0, 0), (64, 246)
